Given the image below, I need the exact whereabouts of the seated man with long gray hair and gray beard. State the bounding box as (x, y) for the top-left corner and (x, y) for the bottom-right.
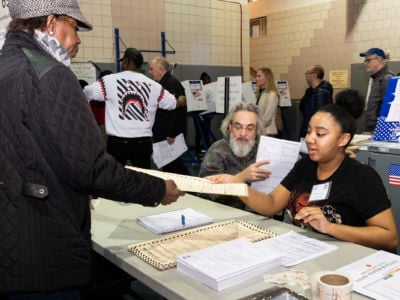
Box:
(199, 102), (271, 209)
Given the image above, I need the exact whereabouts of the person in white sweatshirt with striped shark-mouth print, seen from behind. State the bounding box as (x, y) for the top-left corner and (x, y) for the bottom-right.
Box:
(83, 48), (186, 169)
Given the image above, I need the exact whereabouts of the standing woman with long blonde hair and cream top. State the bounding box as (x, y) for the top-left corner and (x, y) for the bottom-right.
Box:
(256, 68), (279, 136)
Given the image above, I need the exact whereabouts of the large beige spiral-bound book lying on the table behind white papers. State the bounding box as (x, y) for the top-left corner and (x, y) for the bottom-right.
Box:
(128, 220), (276, 270)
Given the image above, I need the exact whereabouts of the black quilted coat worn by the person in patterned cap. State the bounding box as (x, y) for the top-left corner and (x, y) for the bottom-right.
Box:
(0, 32), (165, 293)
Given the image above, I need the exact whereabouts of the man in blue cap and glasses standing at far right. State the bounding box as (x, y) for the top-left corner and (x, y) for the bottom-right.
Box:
(360, 48), (394, 133)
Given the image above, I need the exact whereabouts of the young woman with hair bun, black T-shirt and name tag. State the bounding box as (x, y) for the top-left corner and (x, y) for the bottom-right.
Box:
(209, 89), (398, 251)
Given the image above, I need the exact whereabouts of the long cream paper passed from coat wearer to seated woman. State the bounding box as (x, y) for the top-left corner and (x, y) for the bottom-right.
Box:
(125, 166), (248, 196)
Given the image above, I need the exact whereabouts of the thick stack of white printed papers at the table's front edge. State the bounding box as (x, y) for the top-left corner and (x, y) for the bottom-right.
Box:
(177, 239), (282, 291)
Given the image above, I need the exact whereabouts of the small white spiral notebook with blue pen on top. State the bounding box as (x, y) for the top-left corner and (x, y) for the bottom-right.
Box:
(137, 208), (213, 234)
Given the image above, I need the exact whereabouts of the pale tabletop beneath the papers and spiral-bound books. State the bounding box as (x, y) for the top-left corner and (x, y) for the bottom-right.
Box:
(92, 194), (375, 300)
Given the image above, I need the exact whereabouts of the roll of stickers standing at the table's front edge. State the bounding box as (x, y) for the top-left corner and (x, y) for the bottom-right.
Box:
(311, 271), (353, 300)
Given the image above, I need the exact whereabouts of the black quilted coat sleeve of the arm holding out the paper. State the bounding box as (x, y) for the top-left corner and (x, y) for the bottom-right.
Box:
(32, 67), (165, 205)
